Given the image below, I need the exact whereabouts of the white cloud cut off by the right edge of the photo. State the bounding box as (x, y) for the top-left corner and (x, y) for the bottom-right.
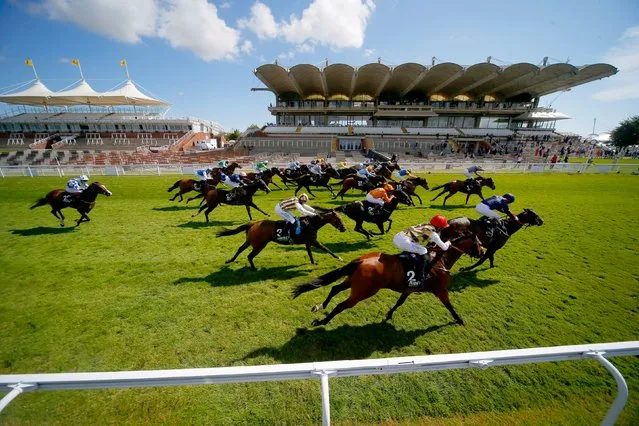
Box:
(593, 26), (639, 101)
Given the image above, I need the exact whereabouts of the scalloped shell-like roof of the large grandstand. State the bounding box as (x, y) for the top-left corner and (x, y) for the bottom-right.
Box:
(254, 62), (617, 100)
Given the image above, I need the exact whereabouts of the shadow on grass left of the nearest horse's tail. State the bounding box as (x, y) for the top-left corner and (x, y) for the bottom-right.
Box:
(173, 265), (308, 287)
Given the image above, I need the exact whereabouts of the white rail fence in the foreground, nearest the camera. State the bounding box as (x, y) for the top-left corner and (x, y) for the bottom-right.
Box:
(0, 341), (639, 425)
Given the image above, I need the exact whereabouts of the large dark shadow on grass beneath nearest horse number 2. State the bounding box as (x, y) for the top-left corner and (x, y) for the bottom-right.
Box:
(243, 320), (455, 363)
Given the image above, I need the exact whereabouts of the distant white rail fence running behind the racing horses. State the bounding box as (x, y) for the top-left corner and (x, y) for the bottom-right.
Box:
(0, 162), (639, 178)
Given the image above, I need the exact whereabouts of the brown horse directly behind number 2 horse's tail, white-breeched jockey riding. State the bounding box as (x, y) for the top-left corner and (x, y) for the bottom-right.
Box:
(217, 210), (346, 269)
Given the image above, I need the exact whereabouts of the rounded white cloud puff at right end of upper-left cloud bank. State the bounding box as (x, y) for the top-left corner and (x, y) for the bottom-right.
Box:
(158, 0), (240, 62)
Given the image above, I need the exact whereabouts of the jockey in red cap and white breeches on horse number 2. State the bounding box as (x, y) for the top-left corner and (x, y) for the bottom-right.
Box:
(393, 215), (450, 288)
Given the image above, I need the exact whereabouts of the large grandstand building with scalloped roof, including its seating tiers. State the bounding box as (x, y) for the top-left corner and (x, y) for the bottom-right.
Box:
(237, 58), (617, 155)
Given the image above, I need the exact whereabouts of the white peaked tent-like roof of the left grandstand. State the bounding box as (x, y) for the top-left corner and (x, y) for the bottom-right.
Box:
(0, 80), (170, 106)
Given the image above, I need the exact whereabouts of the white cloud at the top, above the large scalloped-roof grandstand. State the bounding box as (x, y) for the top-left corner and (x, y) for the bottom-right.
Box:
(238, 0), (375, 52)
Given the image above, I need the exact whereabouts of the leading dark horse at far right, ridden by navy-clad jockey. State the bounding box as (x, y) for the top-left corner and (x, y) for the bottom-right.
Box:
(441, 209), (544, 271)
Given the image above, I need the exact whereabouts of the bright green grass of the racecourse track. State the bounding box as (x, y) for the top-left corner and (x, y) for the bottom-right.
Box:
(0, 174), (639, 425)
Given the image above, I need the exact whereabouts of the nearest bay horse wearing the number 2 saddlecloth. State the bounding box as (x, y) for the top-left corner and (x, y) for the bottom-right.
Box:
(293, 235), (481, 326)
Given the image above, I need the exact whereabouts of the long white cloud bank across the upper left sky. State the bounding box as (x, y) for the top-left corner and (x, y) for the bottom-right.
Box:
(25, 0), (252, 61)
